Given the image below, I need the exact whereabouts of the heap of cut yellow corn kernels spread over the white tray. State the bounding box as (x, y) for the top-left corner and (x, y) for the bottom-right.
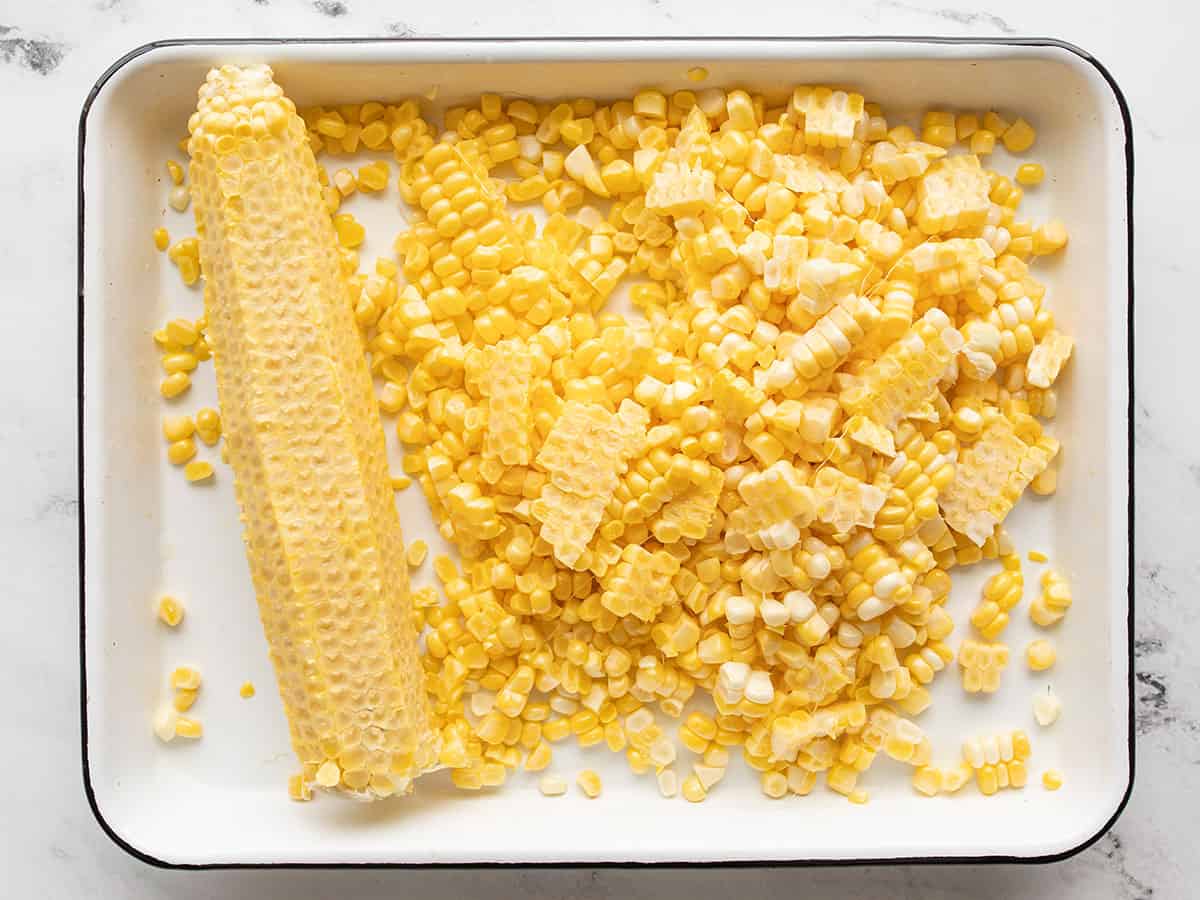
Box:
(162, 79), (1073, 803)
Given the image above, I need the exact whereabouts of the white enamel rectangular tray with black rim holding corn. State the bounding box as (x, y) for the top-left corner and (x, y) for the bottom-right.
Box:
(79, 38), (1133, 866)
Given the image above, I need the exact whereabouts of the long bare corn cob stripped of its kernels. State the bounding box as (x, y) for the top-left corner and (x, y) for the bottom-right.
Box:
(188, 66), (437, 798)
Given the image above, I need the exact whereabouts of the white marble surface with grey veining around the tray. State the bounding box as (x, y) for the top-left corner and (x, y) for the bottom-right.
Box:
(0, 0), (1200, 900)
